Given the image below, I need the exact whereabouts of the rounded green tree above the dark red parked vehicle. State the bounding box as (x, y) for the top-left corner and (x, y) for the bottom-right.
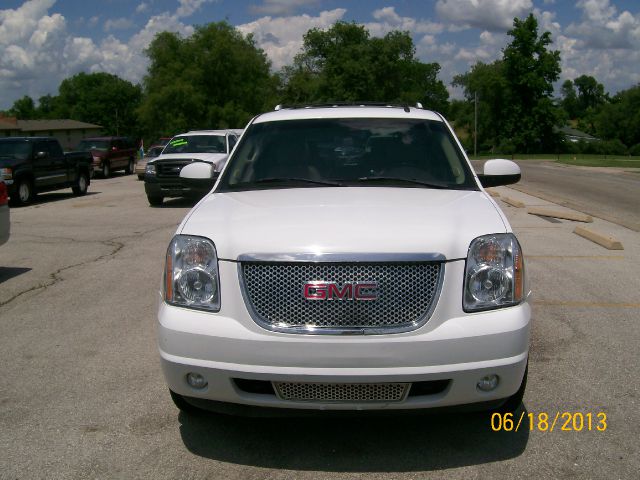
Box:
(54, 72), (142, 136)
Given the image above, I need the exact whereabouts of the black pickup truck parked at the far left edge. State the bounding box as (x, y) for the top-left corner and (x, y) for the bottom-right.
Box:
(0, 137), (93, 205)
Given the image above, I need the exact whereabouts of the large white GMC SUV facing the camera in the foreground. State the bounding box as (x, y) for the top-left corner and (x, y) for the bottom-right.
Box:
(158, 105), (531, 414)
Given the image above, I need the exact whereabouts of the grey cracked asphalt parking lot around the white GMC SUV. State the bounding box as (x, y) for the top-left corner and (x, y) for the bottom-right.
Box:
(0, 171), (640, 479)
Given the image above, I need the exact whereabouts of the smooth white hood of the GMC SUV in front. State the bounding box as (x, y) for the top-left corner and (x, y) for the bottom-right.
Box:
(178, 187), (509, 260)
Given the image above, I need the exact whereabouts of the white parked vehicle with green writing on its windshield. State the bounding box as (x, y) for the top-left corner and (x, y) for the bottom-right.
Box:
(144, 130), (238, 206)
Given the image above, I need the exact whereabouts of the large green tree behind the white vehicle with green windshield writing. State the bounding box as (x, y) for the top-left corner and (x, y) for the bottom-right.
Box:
(138, 22), (277, 137)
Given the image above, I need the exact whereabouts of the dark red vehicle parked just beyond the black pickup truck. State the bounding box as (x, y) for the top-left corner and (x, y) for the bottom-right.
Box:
(76, 137), (138, 178)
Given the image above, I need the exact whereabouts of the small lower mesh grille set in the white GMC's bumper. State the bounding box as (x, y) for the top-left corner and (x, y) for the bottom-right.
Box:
(273, 382), (411, 402)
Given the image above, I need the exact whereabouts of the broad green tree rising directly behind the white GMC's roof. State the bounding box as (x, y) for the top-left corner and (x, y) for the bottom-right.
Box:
(280, 22), (449, 111)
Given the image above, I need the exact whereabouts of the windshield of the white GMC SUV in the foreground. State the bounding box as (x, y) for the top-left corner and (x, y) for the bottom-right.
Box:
(218, 118), (478, 191)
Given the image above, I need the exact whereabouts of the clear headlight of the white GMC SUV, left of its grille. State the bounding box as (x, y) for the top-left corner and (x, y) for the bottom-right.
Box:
(164, 235), (220, 312)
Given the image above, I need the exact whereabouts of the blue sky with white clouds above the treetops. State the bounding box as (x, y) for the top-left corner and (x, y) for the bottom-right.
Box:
(0, 0), (640, 109)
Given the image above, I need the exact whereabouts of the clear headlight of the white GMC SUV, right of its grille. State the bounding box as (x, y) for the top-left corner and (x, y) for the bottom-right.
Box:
(462, 233), (524, 312)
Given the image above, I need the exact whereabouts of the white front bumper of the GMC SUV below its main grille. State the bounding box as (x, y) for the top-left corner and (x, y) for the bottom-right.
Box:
(158, 301), (531, 410)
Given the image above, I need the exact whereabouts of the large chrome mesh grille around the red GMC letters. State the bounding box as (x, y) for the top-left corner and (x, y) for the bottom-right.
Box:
(241, 262), (442, 333)
